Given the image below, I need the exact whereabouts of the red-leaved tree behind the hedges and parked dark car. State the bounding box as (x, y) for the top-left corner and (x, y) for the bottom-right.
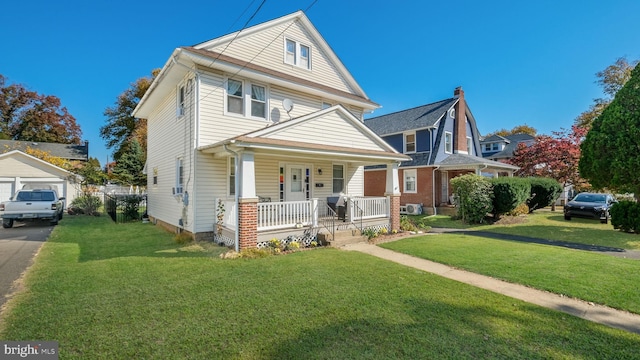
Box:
(508, 125), (589, 190)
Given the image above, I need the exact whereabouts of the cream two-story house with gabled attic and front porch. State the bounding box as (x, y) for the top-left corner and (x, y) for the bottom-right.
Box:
(134, 11), (409, 249)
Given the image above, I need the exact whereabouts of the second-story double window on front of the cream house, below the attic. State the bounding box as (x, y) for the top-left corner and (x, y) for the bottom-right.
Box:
(225, 79), (268, 119)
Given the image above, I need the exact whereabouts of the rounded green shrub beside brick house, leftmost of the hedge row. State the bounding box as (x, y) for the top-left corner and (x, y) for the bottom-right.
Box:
(451, 174), (493, 224)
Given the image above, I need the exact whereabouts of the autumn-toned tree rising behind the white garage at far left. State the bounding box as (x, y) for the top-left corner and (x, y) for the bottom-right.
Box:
(0, 74), (82, 144)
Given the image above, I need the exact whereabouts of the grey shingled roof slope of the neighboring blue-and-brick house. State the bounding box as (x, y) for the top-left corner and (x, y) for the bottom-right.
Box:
(364, 98), (458, 136)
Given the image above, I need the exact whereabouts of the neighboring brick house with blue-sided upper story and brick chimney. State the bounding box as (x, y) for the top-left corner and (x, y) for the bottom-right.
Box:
(364, 88), (518, 213)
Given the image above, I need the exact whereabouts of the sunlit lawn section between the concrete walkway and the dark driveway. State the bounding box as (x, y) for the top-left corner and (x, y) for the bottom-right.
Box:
(380, 234), (640, 314)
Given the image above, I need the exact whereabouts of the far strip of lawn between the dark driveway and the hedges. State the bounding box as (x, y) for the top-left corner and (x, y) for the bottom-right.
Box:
(423, 208), (640, 250)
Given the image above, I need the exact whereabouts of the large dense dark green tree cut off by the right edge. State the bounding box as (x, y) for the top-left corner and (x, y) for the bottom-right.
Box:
(579, 66), (640, 198)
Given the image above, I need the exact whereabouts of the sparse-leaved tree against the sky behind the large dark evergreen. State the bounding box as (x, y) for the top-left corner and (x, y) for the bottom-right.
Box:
(574, 57), (640, 129)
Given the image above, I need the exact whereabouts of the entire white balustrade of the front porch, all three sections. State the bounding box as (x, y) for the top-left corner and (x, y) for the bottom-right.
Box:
(216, 197), (389, 231)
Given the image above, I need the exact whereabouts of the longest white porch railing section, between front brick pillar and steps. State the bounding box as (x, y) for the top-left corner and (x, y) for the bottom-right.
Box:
(258, 200), (317, 231)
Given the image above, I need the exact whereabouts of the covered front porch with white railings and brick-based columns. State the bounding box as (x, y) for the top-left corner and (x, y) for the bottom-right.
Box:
(200, 134), (405, 250)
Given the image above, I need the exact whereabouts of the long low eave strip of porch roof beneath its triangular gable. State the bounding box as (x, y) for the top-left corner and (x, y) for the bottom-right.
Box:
(198, 135), (411, 164)
